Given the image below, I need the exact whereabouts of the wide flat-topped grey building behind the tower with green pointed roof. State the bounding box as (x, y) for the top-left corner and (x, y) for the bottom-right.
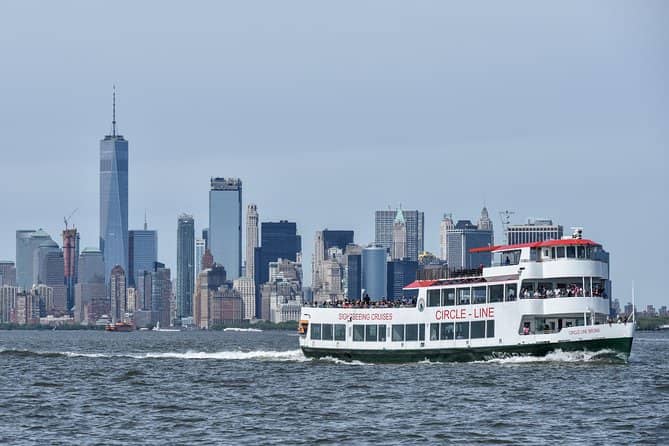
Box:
(374, 210), (425, 261)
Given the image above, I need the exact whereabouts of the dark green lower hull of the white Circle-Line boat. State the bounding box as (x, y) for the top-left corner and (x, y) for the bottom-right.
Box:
(301, 337), (632, 363)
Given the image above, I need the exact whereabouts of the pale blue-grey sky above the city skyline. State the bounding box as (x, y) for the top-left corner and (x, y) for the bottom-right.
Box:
(0, 0), (669, 305)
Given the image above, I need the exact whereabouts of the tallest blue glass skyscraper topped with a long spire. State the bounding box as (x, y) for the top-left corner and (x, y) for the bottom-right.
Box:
(100, 90), (128, 277)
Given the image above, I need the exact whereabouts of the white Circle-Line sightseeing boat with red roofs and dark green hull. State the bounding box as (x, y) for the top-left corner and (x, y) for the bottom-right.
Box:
(298, 231), (635, 362)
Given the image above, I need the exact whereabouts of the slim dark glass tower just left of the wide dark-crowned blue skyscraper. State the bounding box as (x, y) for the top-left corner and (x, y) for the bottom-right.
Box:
(177, 214), (195, 320)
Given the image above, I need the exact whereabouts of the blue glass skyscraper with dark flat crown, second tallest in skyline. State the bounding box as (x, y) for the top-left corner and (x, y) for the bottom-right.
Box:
(209, 178), (242, 280)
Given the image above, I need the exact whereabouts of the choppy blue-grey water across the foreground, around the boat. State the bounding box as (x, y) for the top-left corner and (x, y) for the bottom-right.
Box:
(0, 331), (669, 444)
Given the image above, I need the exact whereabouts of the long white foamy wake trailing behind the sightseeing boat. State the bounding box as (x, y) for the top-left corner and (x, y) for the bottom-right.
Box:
(0, 349), (309, 362)
